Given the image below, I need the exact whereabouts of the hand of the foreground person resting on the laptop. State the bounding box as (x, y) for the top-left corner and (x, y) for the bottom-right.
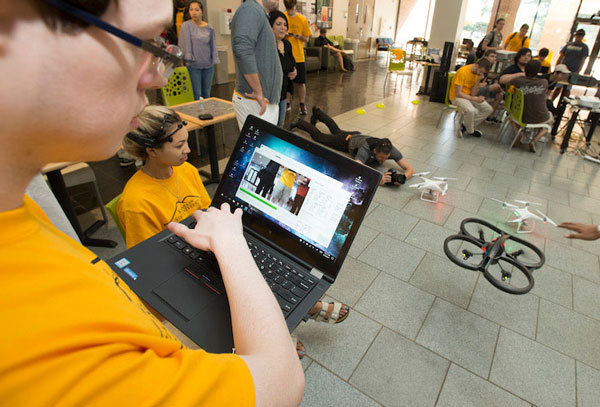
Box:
(167, 203), (245, 253)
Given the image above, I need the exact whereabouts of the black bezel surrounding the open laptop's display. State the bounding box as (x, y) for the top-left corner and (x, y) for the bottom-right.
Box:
(211, 115), (382, 281)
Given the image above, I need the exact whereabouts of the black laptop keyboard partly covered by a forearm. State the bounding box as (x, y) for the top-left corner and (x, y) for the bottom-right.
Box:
(165, 235), (317, 315)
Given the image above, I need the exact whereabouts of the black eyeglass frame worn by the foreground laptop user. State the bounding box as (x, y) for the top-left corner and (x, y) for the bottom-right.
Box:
(46, 0), (182, 66)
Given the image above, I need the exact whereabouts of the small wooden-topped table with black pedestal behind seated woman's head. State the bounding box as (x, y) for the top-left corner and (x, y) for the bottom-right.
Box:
(170, 98), (235, 185)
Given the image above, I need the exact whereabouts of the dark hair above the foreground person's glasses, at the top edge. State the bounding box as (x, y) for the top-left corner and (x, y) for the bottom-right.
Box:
(29, 0), (118, 34)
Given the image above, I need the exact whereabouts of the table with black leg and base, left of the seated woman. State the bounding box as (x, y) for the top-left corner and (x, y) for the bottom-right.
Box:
(41, 162), (117, 247)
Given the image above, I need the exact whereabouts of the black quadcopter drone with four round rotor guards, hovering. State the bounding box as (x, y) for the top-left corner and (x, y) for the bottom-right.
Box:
(444, 218), (545, 294)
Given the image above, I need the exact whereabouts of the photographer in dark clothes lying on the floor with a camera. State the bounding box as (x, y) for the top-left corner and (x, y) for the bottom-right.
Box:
(290, 106), (415, 185)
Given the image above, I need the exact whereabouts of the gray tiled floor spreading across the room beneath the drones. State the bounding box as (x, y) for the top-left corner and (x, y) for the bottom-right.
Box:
(83, 58), (600, 407)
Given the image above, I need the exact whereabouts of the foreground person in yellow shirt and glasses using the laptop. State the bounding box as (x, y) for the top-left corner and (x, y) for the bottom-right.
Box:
(0, 0), (304, 406)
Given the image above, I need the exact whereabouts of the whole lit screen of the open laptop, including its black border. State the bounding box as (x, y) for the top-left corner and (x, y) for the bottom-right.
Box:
(213, 116), (381, 277)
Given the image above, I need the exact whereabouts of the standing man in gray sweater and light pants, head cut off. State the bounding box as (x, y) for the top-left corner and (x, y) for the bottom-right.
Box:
(231, 0), (283, 129)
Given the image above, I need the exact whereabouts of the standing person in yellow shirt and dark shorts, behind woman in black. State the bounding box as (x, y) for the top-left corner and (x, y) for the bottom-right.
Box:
(283, 0), (311, 115)
